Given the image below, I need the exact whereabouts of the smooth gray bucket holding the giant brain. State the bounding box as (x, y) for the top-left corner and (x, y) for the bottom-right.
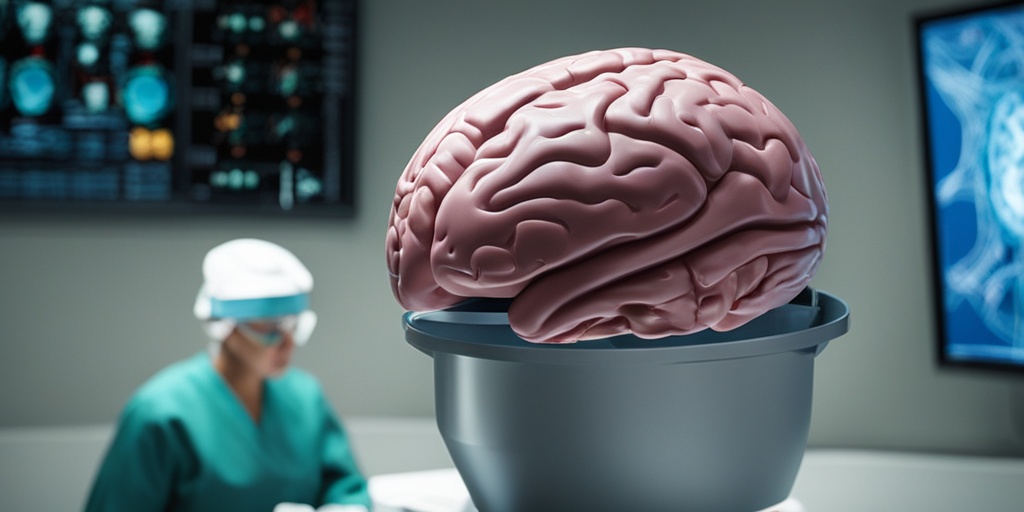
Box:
(404, 289), (849, 512)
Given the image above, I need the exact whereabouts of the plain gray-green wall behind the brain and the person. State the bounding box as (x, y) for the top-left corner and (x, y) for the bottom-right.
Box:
(0, 0), (1020, 453)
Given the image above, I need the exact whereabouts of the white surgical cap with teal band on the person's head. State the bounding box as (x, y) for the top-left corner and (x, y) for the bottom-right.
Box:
(193, 239), (316, 345)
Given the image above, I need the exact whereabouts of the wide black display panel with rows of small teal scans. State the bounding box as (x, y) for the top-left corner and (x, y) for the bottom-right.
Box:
(0, 0), (356, 215)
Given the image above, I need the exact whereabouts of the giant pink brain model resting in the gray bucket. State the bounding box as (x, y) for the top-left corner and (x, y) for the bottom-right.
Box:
(387, 48), (827, 342)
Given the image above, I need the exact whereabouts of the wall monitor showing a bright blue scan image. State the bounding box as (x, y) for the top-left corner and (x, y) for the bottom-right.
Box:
(914, 2), (1024, 371)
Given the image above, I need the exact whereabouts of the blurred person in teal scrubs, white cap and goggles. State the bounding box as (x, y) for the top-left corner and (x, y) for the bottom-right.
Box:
(85, 239), (371, 512)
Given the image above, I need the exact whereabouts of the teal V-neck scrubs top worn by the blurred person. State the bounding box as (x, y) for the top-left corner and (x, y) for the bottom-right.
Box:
(86, 353), (370, 512)
